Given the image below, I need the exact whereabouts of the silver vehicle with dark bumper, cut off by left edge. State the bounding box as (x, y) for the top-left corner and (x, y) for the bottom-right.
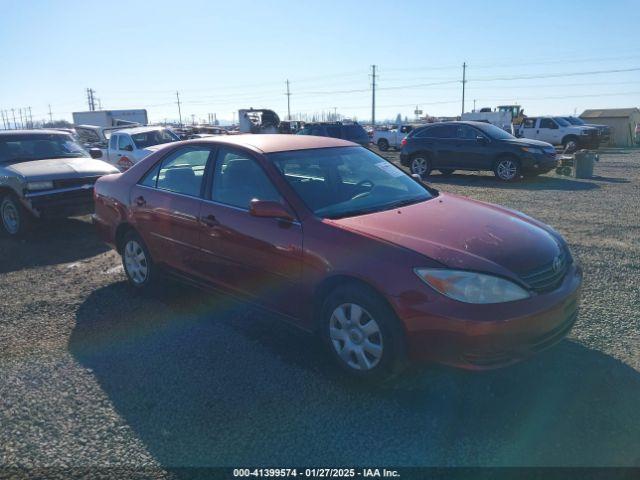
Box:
(0, 130), (118, 236)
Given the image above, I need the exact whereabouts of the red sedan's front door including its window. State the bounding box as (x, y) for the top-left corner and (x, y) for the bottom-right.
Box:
(200, 147), (302, 317)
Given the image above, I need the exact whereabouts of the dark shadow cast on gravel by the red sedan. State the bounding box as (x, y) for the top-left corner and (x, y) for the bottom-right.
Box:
(69, 282), (640, 466)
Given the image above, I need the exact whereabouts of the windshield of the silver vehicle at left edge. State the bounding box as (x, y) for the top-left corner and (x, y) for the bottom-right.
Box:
(0, 134), (89, 163)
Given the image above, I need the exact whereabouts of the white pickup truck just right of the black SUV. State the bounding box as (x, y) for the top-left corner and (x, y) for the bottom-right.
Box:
(519, 117), (600, 152)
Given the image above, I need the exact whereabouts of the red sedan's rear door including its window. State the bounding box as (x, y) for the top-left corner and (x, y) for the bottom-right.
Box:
(131, 146), (212, 273)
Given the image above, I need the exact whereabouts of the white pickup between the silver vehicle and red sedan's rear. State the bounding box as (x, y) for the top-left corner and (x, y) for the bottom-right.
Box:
(90, 127), (180, 171)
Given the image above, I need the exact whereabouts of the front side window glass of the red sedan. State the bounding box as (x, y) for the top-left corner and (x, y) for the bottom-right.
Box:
(211, 148), (281, 209)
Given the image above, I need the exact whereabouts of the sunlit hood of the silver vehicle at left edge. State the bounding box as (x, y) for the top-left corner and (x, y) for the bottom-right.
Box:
(6, 157), (118, 181)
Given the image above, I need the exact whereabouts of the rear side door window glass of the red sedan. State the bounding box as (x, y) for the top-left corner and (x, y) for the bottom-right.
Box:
(156, 147), (211, 197)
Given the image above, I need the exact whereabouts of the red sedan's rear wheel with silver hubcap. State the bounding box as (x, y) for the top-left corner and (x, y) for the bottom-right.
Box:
(121, 230), (158, 292)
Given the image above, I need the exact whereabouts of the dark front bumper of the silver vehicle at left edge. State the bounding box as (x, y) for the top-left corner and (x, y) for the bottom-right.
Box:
(25, 185), (94, 218)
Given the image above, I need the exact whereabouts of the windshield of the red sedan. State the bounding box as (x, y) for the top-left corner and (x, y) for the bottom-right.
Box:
(268, 147), (435, 218)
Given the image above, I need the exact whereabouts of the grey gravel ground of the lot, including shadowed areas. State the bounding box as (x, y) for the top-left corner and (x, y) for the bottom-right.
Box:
(0, 150), (640, 470)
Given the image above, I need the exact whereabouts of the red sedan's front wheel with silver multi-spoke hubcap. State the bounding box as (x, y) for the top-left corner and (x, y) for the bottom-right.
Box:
(320, 283), (407, 383)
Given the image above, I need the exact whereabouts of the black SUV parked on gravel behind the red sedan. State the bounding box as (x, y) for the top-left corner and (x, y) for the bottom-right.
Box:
(400, 122), (557, 181)
